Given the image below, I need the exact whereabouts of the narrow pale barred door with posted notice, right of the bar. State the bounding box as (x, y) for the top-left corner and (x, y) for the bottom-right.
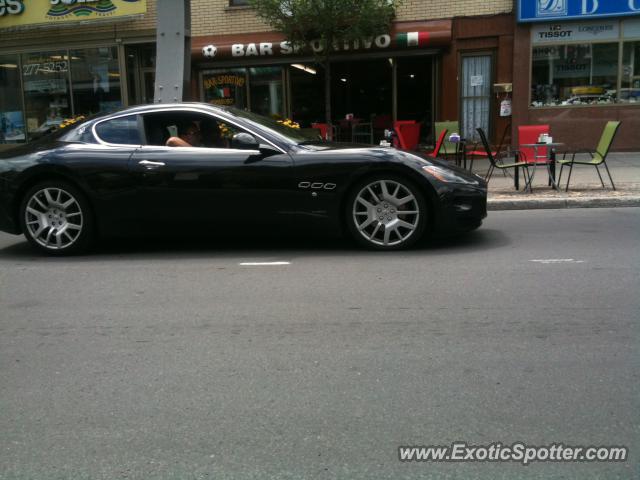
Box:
(460, 54), (493, 140)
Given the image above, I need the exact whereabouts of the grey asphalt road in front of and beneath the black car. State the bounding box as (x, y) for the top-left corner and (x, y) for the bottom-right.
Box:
(0, 208), (640, 480)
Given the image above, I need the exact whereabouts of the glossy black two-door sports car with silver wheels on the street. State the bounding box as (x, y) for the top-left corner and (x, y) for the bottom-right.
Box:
(0, 103), (487, 254)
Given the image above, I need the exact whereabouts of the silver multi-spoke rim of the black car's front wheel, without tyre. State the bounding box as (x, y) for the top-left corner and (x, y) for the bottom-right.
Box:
(352, 180), (420, 247)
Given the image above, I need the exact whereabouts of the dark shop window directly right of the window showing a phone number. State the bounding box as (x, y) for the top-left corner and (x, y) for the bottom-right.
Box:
(70, 47), (122, 115)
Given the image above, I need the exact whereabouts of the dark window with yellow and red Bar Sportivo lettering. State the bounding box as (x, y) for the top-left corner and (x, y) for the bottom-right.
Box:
(202, 68), (247, 109)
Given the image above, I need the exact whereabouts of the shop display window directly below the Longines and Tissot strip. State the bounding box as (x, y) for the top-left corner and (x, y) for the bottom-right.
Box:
(531, 43), (618, 107)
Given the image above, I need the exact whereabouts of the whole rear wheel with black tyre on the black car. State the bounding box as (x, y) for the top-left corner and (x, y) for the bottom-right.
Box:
(19, 180), (94, 255)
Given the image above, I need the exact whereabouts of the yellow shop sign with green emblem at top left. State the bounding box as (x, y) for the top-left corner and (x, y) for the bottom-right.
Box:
(0, 0), (147, 29)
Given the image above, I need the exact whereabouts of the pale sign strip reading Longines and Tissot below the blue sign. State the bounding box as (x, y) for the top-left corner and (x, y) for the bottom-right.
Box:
(531, 20), (620, 44)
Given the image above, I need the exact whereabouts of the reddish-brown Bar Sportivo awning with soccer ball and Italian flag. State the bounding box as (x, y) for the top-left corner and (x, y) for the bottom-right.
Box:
(191, 20), (451, 63)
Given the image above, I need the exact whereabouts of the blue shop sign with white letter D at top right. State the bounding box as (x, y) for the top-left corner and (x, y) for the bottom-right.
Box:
(518, 0), (640, 22)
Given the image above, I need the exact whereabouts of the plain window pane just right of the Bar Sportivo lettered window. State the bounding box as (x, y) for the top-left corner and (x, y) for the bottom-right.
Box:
(249, 67), (284, 117)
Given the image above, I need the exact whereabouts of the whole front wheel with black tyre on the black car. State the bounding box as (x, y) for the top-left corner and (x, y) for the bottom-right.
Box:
(345, 174), (428, 250)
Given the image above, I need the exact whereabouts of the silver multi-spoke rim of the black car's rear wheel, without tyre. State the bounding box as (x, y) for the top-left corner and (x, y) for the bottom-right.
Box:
(24, 187), (83, 250)
